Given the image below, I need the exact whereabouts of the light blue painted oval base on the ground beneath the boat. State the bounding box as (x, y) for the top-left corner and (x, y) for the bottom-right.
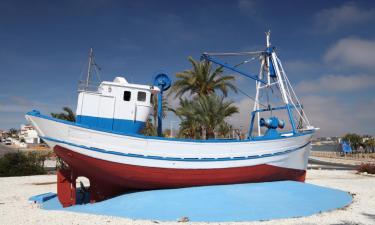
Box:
(37, 181), (352, 222)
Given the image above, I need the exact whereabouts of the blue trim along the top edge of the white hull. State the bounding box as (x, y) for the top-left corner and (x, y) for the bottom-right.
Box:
(26, 110), (314, 143)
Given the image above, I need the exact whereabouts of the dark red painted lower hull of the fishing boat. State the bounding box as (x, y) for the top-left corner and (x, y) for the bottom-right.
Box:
(54, 146), (306, 207)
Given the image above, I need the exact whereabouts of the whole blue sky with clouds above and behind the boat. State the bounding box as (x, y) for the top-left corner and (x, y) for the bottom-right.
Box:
(0, 0), (375, 136)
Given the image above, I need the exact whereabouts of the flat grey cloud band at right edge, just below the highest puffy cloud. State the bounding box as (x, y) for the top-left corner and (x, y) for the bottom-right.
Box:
(295, 74), (375, 93)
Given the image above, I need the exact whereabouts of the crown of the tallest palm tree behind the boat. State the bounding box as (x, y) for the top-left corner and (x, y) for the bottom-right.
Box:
(170, 57), (237, 97)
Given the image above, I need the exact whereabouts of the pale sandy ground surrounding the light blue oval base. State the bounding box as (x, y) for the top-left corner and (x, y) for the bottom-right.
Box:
(0, 170), (375, 225)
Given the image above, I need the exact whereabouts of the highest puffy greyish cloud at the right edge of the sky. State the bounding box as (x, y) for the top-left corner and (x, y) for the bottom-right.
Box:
(324, 38), (375, 69)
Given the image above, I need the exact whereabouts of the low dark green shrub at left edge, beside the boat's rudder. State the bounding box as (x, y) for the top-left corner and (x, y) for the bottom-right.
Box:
(0, 152), (47, 177)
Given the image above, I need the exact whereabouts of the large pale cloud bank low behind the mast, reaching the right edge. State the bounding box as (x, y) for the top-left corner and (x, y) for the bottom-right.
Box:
(228, 69), (375, 136)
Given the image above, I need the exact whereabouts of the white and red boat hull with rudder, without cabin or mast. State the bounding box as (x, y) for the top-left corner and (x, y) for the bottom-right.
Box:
(26, 113), (312, 206)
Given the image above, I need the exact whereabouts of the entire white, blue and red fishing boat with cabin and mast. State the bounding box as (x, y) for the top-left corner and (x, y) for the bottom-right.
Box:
(26, 33), (316, 207)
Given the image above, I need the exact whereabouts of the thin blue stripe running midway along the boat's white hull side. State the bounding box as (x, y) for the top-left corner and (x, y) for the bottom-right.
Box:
(42, 137), (310, 162)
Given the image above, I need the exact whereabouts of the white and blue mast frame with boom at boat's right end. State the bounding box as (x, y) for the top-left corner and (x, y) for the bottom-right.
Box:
(201, 31), (316, 138)
